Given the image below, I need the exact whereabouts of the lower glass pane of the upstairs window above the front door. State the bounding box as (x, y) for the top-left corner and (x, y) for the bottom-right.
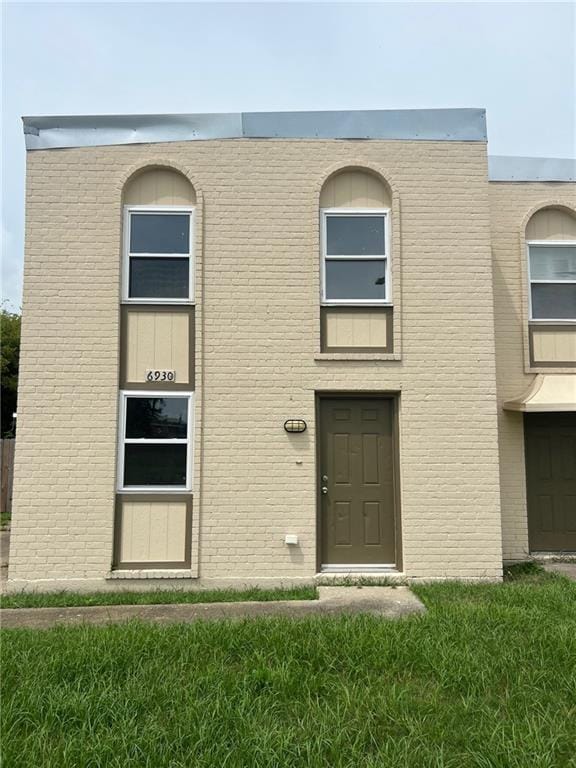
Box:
(326, 259), (386, 300)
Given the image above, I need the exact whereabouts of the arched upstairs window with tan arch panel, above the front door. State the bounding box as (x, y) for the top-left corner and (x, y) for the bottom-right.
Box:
(320, 169), (392, 306)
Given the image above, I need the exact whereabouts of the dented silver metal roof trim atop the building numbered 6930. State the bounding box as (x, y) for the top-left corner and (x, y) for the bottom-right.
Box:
(22, 109), (486, 149)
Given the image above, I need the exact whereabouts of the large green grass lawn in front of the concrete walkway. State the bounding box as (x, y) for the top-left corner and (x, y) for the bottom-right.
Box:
(1, 570), (576, 768)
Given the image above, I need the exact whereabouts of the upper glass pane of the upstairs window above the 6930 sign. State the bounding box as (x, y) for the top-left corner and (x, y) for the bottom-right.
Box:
(130, 213), (190, 253)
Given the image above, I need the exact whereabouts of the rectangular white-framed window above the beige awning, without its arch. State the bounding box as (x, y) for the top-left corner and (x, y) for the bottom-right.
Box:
(527, 240), (576, 323)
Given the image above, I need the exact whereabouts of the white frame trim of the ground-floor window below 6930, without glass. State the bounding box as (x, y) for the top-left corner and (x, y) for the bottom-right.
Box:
(117, 389), (194, 494)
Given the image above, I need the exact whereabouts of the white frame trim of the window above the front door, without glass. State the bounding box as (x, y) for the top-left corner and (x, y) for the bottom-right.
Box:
(320, 208), (393, 307)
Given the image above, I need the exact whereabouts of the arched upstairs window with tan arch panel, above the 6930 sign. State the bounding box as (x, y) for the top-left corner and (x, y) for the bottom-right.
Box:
(122, 167), (196, 303)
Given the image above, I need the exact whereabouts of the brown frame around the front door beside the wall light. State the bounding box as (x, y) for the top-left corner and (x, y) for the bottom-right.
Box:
(314, 389), (404, 573)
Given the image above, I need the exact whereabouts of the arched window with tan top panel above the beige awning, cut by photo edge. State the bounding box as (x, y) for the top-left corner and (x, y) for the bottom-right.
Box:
(526, 208), (576, 323)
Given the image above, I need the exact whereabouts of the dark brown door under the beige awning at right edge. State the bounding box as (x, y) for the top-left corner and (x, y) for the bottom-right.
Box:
(524, 413), (576, 552)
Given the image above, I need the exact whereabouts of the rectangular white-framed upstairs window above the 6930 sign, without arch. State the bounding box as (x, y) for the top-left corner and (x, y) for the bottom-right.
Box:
(122, 205), (194, 304)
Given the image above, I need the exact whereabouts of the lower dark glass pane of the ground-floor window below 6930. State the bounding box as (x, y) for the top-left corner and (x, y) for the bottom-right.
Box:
(124, 443), (186, 487)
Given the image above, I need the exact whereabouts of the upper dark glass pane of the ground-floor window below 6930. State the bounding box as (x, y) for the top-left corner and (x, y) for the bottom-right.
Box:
(126, 397), (188, 440)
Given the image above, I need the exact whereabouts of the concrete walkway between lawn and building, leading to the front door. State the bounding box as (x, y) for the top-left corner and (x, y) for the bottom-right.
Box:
(0, 587), (426, 629)
